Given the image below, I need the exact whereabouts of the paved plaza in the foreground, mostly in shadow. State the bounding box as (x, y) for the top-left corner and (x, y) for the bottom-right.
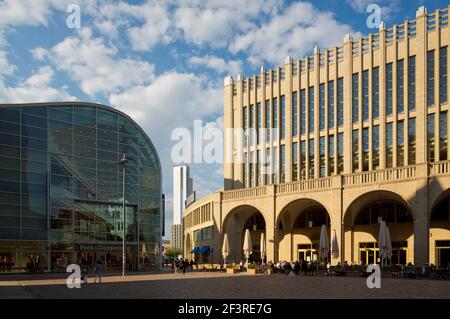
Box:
(0, 273), (450, 299)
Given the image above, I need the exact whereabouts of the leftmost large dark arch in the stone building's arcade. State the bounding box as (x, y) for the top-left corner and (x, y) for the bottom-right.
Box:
(222, 204), (267, 263)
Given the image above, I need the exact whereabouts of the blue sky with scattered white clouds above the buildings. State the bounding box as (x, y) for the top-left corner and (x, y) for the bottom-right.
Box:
(0, 0), (448, 235)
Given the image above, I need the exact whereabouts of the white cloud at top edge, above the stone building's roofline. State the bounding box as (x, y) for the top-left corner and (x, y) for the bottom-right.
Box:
(230, 2), (360, 64)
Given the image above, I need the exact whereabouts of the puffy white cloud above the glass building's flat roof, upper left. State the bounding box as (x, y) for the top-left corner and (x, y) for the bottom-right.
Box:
(33, 28), (154, 97)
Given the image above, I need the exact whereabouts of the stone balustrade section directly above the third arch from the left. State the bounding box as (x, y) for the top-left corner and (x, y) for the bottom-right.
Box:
(343, 166), (416, 186)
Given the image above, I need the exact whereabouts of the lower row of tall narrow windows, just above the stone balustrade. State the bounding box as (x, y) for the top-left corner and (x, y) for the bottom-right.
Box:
(243, 111), (448, 187)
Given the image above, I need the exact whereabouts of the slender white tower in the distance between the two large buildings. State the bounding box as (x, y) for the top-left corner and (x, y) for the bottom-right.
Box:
(170, 165), (193, 251)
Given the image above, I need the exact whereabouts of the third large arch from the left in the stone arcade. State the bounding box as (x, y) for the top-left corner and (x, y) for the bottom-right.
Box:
(343, 190), (415, 264)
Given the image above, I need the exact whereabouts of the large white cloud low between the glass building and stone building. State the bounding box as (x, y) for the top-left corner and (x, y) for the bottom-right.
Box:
(109, 71), (223, 205)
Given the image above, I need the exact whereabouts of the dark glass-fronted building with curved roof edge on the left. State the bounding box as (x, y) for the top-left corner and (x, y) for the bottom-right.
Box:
(0, 102), (162, 271)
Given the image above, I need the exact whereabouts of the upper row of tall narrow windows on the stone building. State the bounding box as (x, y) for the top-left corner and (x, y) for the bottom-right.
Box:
(243, 47), (448, 147)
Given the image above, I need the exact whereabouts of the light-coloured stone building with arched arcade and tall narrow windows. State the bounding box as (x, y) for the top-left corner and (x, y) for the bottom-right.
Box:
(184, 8), (450, 265)
